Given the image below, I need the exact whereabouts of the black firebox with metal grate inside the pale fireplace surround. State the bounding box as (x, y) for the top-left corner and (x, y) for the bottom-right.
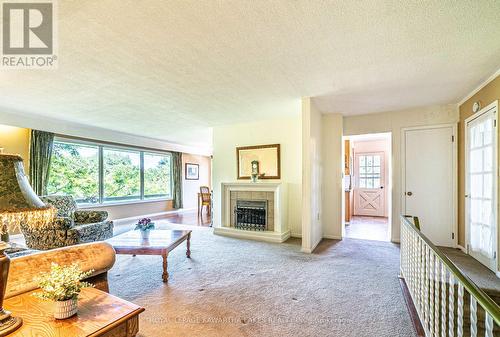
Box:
(234, 199), (267, 231)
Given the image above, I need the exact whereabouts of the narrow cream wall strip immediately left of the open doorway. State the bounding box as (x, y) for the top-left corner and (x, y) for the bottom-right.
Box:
(322, 114), (344, 239)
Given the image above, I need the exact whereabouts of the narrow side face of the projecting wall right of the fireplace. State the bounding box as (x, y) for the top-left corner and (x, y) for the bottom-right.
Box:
(302, 98), (323, 253)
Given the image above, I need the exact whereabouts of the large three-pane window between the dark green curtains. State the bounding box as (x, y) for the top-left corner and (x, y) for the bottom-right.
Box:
(48, 138), (172, 205)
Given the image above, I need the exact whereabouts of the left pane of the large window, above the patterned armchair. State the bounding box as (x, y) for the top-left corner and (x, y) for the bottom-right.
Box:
(47, 141), (99, 204)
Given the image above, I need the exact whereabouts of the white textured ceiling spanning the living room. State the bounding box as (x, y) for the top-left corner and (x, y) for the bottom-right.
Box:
(0, 0), (500, 145)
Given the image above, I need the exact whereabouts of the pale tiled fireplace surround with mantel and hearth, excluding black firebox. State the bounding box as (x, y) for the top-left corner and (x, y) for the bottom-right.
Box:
(214, 182), (290, 242)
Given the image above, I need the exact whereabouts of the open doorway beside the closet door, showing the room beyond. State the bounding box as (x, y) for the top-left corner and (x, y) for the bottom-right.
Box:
(344, 133), (392, 241)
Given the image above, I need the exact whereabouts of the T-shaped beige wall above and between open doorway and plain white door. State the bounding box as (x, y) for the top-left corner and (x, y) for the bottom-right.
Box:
(344, 105), (459, 242)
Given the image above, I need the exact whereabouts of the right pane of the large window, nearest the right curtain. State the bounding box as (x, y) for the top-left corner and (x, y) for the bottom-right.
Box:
(144, 153), (171, 198)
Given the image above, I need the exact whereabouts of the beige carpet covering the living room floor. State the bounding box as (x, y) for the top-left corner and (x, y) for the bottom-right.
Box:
(110, 224), (414, 337)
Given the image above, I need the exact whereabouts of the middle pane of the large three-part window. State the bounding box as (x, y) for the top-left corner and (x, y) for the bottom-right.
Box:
(103, 148), (141, 202)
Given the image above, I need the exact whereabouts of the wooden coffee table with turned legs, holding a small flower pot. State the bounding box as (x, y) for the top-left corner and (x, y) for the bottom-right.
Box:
(106, 229), (191, 282)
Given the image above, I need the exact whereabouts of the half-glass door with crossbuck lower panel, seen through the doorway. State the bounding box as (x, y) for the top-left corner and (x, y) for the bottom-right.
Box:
(354, 152), (385, 216)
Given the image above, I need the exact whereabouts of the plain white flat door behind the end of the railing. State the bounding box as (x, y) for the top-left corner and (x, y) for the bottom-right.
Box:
(402, 126), (456, 247)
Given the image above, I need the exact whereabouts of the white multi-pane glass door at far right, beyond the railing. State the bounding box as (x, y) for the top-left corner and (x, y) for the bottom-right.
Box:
(465, 107), (497, 271)
